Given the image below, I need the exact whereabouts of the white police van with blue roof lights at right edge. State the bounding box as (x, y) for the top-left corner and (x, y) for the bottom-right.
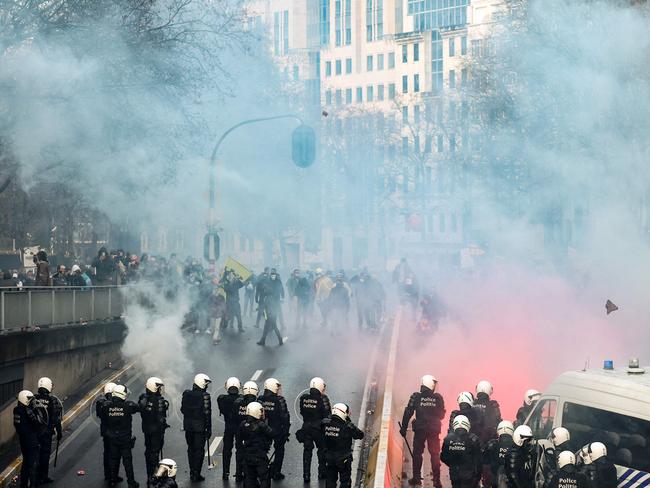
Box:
(526, 359), (650, 488)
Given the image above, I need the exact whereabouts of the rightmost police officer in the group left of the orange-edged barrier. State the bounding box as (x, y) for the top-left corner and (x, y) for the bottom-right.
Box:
(321, 403), (363, 488)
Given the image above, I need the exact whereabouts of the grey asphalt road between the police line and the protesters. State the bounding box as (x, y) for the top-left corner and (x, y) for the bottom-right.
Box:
(39, 319), (378, 488)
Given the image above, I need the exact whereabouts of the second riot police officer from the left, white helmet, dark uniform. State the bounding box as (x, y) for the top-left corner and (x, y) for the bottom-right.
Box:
(34, 377), (63, 484)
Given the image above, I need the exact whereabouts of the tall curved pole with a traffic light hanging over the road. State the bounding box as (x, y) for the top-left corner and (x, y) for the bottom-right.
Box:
(203, 114), (315, 265)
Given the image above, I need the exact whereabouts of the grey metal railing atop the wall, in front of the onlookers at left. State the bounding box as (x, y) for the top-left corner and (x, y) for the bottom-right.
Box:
(0, 286), (124, 332)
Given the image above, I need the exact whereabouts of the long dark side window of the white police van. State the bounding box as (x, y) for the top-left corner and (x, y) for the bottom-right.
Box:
(562, 402), (650, 472)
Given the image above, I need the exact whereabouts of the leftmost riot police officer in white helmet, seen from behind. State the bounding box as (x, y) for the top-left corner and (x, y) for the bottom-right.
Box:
(14, 390), (40, 488)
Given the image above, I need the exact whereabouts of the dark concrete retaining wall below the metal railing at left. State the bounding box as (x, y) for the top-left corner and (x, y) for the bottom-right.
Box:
(0, 321), (126, 447)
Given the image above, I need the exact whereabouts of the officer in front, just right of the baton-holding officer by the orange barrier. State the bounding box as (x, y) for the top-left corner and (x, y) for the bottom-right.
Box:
(440, 415), (482, 488)
